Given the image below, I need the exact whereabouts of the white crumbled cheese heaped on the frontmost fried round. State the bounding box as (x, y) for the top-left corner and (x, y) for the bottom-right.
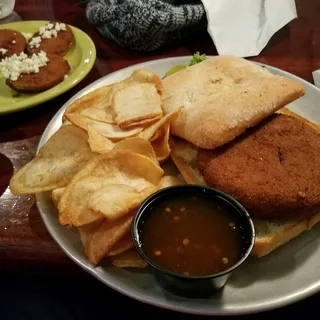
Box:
(0, 51), (49, 81)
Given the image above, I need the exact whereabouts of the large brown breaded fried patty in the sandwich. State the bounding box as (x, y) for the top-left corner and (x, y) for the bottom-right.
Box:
(197, 115), (320, 219)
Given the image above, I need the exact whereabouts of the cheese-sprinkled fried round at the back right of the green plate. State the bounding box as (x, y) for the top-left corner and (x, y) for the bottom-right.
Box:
(28, 22), (74, 56)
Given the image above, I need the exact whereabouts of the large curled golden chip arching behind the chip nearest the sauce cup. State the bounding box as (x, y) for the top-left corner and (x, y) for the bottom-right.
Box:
(58, 150), (163, 226)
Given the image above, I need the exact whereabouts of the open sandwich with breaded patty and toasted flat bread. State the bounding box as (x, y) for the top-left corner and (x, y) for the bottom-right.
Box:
(162, 56), (320, 257)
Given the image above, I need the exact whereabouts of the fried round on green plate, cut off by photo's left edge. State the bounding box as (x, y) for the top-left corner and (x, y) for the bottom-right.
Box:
(0, 29), (27, 59)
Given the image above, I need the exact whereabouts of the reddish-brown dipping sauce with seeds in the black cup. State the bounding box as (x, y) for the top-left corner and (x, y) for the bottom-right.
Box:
(139, 194), (244, 276)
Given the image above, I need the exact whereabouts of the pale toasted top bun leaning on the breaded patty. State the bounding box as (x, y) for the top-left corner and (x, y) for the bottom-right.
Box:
(162, 56), (305, 149)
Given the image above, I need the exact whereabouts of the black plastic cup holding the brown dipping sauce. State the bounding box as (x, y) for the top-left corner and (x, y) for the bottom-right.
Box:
(131, 185), (255, 298)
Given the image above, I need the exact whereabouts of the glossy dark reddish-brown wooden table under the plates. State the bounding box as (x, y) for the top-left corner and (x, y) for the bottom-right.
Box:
(0, 0), (320, 318)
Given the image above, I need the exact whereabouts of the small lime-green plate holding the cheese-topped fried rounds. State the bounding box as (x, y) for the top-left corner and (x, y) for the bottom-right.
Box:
(0, 21), (96, 114)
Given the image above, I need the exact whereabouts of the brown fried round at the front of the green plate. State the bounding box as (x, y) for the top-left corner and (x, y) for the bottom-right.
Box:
(7, 55), (70, 93)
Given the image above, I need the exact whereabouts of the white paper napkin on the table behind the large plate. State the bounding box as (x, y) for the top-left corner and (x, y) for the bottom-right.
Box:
(201, 0), (297, 57)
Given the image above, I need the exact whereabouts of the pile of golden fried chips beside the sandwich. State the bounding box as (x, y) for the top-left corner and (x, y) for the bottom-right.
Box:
(10, 69), (181, 267)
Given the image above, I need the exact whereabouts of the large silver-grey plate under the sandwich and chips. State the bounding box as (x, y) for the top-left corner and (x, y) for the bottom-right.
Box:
(37, 57), (320, 315)
